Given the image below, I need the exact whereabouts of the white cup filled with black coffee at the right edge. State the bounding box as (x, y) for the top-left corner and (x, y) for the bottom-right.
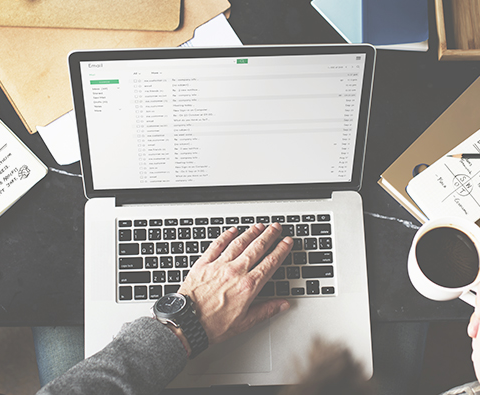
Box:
(408, 217), (480, 306)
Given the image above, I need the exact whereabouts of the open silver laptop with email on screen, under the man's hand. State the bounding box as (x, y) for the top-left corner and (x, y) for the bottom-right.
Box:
(69, 45), (375, 388)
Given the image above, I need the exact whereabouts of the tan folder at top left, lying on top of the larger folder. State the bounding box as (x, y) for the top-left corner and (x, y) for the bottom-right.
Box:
(0, 0), (182, 31)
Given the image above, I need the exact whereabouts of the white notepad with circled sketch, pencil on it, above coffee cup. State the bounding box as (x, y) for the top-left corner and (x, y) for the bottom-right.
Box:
(407, 130), (480, 222)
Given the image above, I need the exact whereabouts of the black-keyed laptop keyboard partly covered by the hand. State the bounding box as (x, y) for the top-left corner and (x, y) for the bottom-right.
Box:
(117, 213), (336, 302)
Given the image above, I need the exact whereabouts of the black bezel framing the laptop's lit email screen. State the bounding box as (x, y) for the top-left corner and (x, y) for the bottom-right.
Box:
(68, 44), (376, 202)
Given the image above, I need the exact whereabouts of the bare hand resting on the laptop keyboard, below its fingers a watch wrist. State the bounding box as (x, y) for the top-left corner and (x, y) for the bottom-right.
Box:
(178, 223), (293, 344)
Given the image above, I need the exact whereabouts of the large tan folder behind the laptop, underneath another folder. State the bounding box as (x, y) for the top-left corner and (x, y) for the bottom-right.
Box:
(0, 0), (230, 133)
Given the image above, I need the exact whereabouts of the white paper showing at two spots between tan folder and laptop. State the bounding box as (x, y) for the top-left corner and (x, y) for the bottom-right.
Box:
(37, 14), (242, 166)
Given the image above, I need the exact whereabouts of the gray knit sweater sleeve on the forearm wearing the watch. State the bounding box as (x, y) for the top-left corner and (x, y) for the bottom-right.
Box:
(37, 317), (187, 395)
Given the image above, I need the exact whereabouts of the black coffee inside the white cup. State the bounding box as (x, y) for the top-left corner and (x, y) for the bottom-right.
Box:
(415, 226), (479, 288)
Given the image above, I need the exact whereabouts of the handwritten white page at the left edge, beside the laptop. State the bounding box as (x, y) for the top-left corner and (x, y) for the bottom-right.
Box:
(0, 121), (48, 215)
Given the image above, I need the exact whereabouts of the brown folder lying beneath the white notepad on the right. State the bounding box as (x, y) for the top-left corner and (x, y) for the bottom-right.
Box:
(378, 78), (480, 223)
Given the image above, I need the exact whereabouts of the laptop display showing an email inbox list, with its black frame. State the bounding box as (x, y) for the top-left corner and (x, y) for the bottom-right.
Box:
(70, 46), (373, 203)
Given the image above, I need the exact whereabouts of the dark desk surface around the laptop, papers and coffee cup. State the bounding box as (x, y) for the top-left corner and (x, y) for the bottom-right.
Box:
(0, 0), (480, 326)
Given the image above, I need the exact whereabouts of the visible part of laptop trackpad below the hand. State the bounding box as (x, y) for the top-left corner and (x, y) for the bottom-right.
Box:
(187, 321), (272, 375)
